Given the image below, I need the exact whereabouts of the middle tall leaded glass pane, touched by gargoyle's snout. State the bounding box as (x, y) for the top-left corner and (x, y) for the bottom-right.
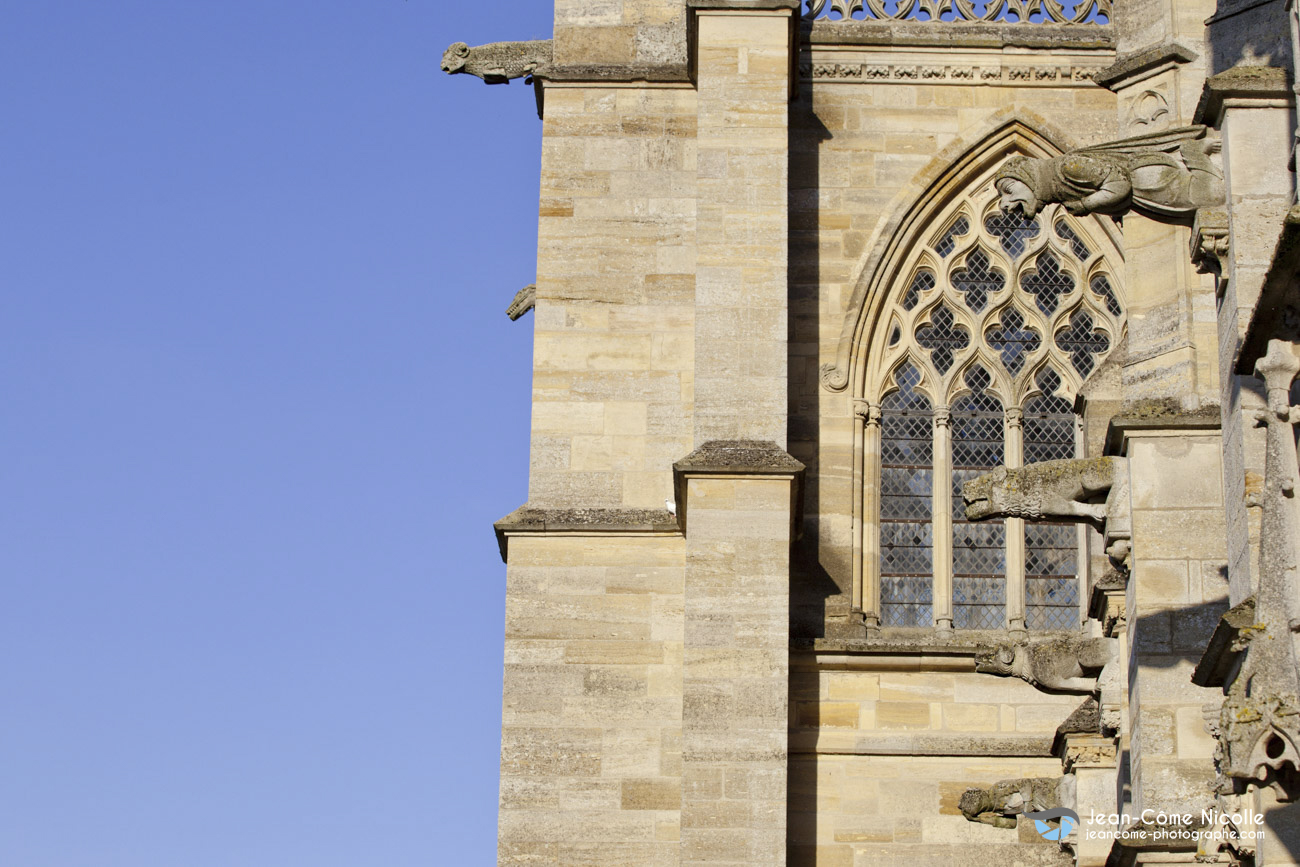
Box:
(950, 365), (1006, 629)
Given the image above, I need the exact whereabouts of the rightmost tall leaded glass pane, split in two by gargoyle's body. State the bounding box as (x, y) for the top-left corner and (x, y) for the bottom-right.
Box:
(1024, 368), (1079, 629)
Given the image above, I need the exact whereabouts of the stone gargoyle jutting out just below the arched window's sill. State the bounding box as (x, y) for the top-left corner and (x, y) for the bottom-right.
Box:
(975, 637), (1115, 694)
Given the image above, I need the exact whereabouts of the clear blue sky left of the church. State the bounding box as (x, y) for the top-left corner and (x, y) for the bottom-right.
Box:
(0, 0), (551, 867)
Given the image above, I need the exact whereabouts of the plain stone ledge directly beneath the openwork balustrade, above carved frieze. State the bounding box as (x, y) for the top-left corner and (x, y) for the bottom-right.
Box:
(801, 21), (1117, 51)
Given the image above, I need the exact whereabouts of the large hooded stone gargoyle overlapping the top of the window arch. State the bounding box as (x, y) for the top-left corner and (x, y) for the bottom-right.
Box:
(993, 126), (1223, 222)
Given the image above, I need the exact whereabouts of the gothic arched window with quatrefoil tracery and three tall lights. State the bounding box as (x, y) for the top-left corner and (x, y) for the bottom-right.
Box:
(863, 175), (1123, 629)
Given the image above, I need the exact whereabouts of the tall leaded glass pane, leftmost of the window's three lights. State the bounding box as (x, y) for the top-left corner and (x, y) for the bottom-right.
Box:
(880, 364), (935, 627)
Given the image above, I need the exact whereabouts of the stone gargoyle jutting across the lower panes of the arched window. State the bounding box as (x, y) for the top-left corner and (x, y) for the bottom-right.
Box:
(962, 458), (1128, 529)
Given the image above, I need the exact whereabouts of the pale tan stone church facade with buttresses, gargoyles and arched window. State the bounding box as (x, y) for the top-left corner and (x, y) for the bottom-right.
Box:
(442, 0), (1300, 867)
